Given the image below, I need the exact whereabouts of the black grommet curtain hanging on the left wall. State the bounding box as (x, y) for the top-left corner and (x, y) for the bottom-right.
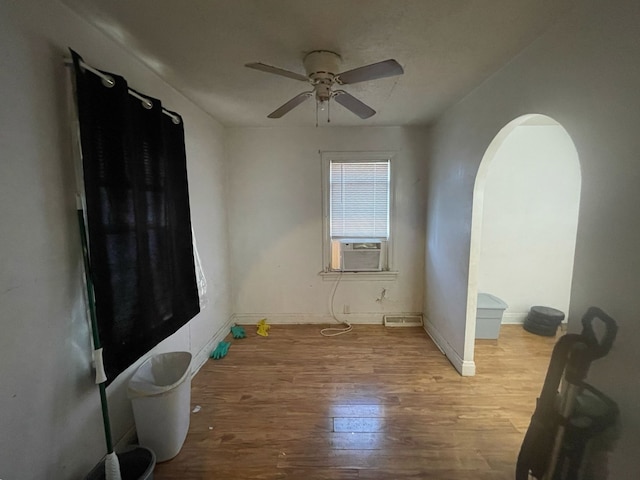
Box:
(72, 51), (200, 383)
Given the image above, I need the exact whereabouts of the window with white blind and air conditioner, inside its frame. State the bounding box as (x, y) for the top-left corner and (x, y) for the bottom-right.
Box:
(322, 152), (392, 272)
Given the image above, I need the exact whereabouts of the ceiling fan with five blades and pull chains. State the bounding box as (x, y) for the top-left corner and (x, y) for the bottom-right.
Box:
(245, 50), (404, 123)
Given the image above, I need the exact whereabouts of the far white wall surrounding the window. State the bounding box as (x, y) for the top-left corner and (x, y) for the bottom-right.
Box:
(228, 126), (427, 323)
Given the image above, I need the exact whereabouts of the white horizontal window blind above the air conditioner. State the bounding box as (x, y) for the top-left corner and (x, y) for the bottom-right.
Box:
(329, 160), (389, 238)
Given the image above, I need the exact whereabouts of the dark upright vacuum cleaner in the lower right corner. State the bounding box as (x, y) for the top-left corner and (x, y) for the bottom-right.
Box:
(516, 307), (619, 480)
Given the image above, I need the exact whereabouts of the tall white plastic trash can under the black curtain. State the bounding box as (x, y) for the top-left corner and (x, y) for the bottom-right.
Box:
(128, 352), (191, 462)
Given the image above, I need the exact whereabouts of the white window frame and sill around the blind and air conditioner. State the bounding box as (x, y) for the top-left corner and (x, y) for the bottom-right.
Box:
(320, 151), (397, 280)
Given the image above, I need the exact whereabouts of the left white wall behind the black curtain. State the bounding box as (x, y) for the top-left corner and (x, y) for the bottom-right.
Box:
(0, 0), (231, 480)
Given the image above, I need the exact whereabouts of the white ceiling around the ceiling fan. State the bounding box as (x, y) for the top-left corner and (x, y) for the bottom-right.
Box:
(61, 0), (576, 126)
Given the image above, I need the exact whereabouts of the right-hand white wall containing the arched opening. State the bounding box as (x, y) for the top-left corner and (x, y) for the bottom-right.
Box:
(425, 0), (640, 472)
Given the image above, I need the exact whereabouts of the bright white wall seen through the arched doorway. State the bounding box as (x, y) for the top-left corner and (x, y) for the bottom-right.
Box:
(476, 125), (580, 323)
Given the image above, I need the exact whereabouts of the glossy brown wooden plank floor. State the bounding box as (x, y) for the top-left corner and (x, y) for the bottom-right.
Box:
(154, 325), (555, 480)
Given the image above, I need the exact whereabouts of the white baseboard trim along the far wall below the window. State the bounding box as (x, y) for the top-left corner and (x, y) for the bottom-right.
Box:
(233, 312), (422, 325)
